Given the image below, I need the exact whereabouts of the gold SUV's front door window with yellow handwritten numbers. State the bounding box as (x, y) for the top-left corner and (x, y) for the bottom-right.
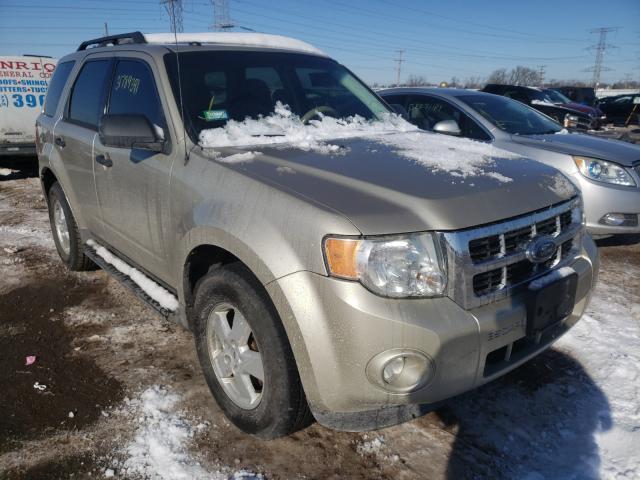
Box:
(109, 60), (166, 129)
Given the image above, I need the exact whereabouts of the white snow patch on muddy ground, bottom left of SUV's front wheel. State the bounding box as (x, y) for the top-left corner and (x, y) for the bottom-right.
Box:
(111, 386), (263, 480)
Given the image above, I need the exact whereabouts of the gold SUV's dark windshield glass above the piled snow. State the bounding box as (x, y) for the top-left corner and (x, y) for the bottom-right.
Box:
(165, 51), (389, 139)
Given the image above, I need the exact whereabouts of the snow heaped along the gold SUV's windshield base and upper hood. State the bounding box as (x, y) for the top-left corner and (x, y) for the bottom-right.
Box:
(200, 102), (520, 182)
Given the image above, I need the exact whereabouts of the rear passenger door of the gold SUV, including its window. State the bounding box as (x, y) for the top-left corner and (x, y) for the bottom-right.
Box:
(53, 54), (112, 234)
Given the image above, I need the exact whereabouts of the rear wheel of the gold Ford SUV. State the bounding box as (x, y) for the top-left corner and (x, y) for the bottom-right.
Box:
(48, 182), (95, 272)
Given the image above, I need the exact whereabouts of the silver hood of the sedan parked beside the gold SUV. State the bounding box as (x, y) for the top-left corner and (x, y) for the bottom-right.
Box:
(511, 133), (640, 167)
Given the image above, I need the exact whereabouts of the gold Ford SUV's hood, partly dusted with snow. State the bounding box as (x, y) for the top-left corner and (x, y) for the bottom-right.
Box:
(201, 132), (576, 235)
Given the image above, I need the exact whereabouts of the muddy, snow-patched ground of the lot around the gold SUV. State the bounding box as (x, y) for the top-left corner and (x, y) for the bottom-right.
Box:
(0, 166), (640, 480)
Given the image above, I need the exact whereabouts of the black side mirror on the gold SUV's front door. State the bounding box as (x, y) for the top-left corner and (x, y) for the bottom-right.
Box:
(98, 113), (165, 152)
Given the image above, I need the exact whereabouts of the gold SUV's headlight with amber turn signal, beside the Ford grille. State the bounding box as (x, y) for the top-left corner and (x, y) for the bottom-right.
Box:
(324, 233), (447, 298)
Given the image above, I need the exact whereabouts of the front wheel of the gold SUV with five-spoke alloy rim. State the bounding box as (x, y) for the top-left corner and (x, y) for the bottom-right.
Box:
(193, 263), (312, 438)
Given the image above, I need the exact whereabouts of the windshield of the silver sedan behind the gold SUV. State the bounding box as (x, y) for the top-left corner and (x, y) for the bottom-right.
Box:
(457, 94), (562, 135)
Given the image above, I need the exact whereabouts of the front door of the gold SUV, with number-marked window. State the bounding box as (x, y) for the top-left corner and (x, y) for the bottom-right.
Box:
(95, 52), (172, 279)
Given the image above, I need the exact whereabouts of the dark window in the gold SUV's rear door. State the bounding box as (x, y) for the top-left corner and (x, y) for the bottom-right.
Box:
(68, 60), (111, 130)
